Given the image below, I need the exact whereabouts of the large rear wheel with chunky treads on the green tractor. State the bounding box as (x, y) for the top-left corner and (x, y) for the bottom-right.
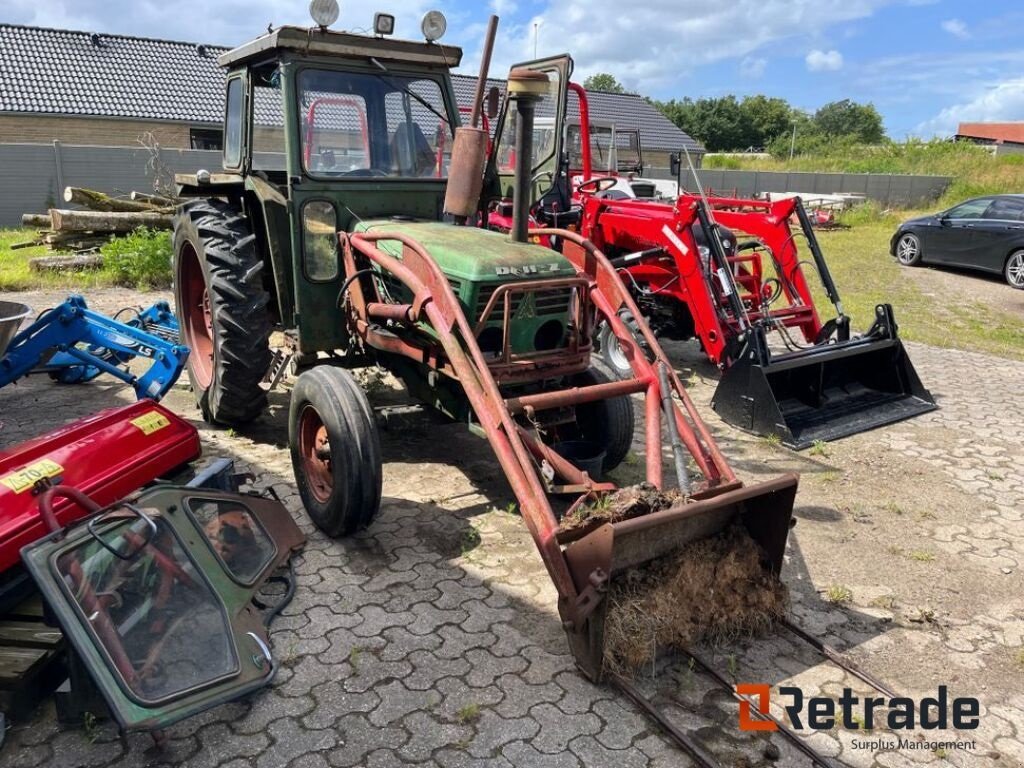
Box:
(174, 200), (270, 425)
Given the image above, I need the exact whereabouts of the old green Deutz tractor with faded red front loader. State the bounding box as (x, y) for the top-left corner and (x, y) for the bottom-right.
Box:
(174, 7), (796, 678)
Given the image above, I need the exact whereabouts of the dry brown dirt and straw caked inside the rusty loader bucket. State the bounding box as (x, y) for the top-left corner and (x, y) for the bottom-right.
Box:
(604, 523), (788, 674)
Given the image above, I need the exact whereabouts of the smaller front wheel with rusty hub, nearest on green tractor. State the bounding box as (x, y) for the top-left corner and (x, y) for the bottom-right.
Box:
(288, 366), (382, 538)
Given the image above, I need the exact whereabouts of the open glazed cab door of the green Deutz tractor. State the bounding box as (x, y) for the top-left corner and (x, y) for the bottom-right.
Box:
(488, 53), (572, 201)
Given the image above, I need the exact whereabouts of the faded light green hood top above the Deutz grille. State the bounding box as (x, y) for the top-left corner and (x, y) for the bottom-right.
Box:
(354, 219), (575, 283)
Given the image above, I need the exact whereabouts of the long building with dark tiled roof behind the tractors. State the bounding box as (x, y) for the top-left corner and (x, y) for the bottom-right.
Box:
(0, 24), (703, 167)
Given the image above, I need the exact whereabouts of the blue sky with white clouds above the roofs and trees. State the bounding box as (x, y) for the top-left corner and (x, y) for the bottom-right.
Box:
(0, 0), (1024, 138)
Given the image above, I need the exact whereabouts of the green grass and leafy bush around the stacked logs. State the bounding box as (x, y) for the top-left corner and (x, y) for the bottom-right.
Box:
(0, 228), (171, 291)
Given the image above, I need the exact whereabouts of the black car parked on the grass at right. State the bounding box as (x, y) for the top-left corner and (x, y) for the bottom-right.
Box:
(889, 195), (1024, 290)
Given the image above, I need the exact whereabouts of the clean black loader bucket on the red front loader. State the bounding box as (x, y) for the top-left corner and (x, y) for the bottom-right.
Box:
(712, 304), (938, 451)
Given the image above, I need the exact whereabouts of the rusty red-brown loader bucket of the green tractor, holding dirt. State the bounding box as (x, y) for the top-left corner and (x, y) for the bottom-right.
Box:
(565, 474), (799, 682)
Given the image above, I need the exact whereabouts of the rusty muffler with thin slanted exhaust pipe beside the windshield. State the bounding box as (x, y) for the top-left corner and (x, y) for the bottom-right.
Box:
(444, 15), (498, 225)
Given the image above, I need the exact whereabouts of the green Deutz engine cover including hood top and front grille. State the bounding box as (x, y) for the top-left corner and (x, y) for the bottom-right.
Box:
(355, 219), (575, 354)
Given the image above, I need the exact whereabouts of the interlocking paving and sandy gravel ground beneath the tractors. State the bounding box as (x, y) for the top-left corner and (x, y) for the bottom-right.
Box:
(0, 288), (1024, 768)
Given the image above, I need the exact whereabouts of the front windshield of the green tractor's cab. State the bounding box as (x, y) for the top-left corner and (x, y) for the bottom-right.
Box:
(298, 70), (452, 178)
